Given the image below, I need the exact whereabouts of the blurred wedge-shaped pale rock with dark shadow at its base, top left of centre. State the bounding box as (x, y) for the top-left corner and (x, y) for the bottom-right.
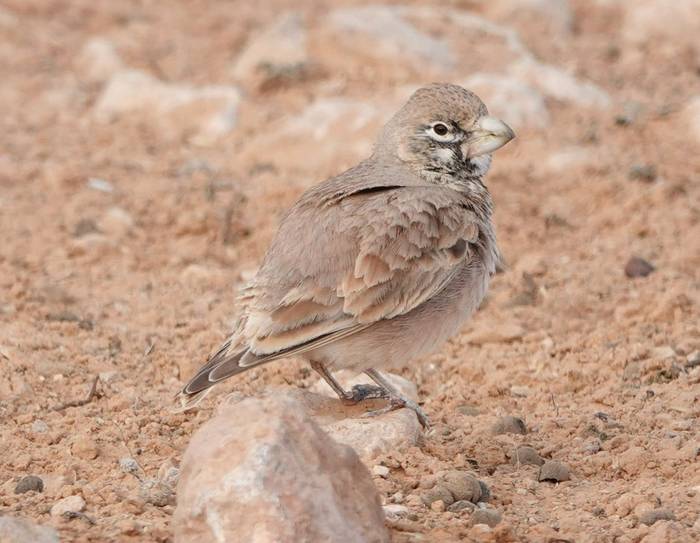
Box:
(233, 12), (308, 81)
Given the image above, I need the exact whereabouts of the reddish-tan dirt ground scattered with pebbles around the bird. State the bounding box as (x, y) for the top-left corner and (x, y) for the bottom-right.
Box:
(0, 0), (700, 542)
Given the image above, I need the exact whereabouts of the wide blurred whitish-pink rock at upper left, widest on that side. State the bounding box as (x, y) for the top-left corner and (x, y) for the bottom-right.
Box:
(94, 70), (240, 144)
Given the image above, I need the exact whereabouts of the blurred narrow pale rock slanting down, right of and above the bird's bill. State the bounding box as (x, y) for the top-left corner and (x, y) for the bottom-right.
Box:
(509, 58), (611, 108)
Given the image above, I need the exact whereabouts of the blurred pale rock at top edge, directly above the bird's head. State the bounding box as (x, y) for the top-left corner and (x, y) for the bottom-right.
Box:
(328, 5), (456, 68)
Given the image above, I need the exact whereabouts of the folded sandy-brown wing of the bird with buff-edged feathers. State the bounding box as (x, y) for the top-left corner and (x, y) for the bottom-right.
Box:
(238, 186), (481, 364)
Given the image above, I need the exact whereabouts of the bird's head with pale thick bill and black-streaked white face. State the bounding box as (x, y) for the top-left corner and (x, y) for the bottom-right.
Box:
(377, 84), (515, 182)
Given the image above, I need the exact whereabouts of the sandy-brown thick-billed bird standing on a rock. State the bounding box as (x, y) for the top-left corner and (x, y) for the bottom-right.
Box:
(178, 83), (515, 428)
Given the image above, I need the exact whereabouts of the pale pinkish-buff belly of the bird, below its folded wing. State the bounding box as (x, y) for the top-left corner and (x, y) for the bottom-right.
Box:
(306, 263), (489, 371)
